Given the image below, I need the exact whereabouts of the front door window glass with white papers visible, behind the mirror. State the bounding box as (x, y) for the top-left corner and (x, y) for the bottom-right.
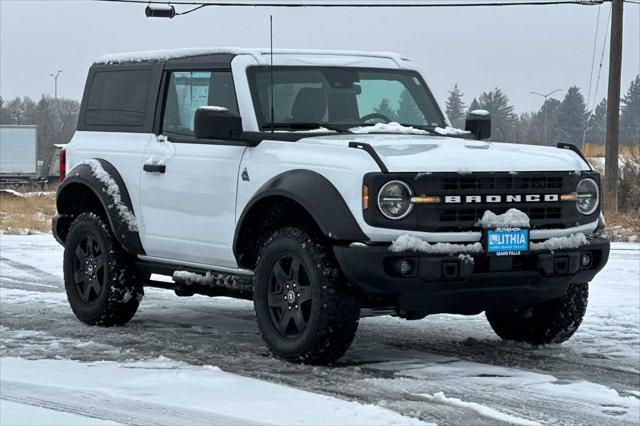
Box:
(162, 71), (238, 136)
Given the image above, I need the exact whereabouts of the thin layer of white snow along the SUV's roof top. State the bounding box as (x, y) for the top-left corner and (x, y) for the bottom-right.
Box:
(94, 47), (409, 64)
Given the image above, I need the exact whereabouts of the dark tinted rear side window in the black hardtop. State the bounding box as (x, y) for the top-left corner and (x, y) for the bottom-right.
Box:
(84, 70), (152, 127)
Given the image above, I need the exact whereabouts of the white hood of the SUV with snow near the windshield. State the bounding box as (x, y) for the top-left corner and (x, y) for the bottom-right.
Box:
(299, 134), (590, 173)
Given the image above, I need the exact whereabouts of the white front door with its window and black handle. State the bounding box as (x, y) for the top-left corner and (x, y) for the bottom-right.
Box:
(139, 71), (246, 267)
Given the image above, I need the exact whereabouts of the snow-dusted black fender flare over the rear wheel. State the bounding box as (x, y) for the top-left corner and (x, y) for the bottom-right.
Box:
(53, 159), (145, 255)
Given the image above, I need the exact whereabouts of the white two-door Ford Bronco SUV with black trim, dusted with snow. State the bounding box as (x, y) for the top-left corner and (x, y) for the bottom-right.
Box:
(53, 49), (609, 363)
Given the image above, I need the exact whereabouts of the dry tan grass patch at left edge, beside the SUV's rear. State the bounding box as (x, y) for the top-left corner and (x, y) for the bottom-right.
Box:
(0, 193), (56, 234)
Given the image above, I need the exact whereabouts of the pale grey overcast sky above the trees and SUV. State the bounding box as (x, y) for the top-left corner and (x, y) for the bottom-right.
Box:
(0, 0), (640, 112)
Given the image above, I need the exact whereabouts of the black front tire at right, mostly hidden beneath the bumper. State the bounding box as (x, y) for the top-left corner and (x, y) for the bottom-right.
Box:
(486, 284), (589, 345)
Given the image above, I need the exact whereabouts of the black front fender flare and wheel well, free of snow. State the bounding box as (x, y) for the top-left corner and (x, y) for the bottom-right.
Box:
(233, 170), (368, 268)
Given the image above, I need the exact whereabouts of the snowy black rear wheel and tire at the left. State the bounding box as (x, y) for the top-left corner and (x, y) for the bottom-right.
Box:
(64, 213), (144, 327)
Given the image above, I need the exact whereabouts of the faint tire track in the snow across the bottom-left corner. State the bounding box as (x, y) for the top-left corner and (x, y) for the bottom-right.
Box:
(0, 380), (264, 426)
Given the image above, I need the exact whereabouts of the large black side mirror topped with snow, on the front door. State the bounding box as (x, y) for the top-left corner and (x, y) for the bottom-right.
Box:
(193, 106), (242, 140)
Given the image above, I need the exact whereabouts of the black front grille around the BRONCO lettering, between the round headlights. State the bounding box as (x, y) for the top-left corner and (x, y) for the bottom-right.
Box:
(364, 171), (600, 232)
